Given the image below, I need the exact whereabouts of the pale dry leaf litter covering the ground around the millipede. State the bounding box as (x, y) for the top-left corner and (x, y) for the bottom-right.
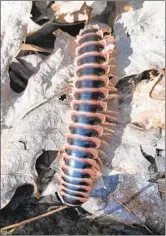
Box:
(1, 1), (165, 233)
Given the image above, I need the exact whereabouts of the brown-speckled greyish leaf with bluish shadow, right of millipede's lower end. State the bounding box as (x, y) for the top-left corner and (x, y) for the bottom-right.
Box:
(82, 174), (164, 233)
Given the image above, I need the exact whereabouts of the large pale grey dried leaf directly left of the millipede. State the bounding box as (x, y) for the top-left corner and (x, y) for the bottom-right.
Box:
(1, 32), (75, 207)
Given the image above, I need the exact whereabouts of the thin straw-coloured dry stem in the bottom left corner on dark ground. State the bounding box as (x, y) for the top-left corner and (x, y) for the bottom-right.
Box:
(0, 206), (68, 233)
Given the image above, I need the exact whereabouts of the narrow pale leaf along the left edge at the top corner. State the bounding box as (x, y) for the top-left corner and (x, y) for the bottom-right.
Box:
(1, 1), (32, 83)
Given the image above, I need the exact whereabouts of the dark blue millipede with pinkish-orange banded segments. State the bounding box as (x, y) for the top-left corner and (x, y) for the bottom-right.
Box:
(58, 25), (118, 206)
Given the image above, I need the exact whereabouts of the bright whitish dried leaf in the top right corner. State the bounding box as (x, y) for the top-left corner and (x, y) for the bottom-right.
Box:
(114, 0), (165, 78)
